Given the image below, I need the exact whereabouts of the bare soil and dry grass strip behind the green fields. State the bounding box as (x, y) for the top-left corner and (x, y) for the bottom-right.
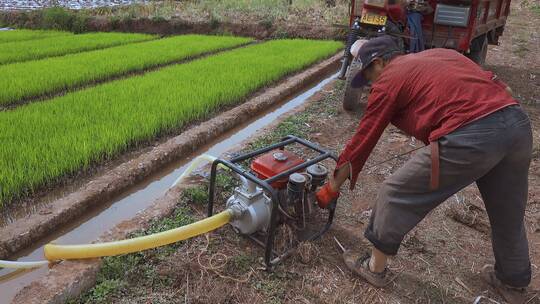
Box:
(0, 0), (349, 40)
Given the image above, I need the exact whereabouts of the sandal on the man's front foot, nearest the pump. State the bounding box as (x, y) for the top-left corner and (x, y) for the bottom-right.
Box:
(343, 251), (395, 288)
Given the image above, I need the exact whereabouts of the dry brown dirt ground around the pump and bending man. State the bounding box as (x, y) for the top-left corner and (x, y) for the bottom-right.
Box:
(74, 6), (540, 303)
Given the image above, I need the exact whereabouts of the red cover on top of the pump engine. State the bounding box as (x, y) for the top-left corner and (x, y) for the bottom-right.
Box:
(251, 150), (304, 189)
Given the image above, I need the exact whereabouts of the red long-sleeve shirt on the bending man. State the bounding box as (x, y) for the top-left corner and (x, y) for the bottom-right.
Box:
(337, 49), (517, 189)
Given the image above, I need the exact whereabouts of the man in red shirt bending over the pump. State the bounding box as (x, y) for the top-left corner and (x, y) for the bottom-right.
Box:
(317, 36), (532, 303)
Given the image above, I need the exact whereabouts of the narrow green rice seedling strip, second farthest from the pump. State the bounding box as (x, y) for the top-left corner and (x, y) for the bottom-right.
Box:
(0, 33), (157, 64)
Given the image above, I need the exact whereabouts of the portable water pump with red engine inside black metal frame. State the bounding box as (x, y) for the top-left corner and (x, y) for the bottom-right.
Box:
(208, 136), (337, 269)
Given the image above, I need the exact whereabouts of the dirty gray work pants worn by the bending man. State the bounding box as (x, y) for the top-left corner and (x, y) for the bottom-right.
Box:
(365, 106), (532, 287)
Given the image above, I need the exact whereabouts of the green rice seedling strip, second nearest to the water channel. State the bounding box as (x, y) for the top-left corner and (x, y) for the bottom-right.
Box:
(0, 35), (253, 106)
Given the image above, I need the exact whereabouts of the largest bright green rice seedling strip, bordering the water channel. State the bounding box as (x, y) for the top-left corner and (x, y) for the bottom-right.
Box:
(0, 40), (342, 206)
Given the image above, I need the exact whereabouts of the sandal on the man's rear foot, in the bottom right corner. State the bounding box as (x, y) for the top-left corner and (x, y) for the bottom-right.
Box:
(480, 265), (540, 304)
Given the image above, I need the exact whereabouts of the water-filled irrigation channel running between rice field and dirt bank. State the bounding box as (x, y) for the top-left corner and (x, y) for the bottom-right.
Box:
(0, 74), (337, 303)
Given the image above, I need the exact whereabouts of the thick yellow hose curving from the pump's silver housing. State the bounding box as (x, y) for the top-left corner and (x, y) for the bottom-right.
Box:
(44, 209), (232, 261)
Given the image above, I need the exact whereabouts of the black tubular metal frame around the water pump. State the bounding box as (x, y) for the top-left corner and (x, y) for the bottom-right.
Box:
(208, 135), (337, 270)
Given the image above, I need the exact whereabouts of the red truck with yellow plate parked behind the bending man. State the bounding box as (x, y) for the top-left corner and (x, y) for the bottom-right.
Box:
(338, 0), (511, 110)
